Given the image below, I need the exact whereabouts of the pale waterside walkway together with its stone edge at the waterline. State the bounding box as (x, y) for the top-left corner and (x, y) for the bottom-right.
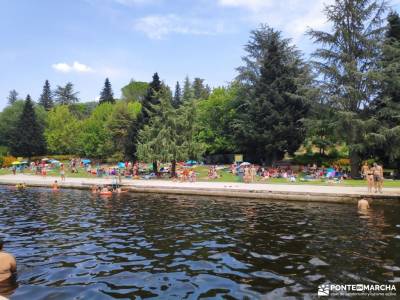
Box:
(0, 174), (400, 204)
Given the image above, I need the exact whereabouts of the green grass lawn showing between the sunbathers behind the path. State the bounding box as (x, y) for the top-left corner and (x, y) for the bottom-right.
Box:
(0, 166), (400, 187)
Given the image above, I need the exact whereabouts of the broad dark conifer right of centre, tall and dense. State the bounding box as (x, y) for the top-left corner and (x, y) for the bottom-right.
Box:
(233, 25), (312, 164)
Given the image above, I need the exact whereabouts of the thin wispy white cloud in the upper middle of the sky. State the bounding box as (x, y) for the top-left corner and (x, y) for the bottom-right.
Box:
(134, 14), (224, 39)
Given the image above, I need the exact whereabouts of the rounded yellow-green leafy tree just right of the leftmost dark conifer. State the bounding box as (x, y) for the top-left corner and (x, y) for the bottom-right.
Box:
(44, 105), (81, 154)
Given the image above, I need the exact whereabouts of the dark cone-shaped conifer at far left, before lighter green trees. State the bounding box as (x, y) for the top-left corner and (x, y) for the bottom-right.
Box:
(11, 95), (46, 158)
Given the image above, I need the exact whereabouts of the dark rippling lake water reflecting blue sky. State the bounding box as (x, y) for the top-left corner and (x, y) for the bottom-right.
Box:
(0, 188), (400, 299)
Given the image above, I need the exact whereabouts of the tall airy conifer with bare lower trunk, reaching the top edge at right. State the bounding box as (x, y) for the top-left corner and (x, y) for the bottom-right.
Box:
(309, 0), (386, 177)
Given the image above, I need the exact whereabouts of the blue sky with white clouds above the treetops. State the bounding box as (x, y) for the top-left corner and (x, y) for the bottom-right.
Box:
(0, 0), (400, 109)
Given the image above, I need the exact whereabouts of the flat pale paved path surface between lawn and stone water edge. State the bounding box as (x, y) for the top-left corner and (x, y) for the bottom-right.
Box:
(0, 174), (400, 196)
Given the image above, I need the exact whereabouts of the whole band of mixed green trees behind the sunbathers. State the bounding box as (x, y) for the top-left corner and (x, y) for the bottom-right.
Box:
(0, 0), (400, 177)
